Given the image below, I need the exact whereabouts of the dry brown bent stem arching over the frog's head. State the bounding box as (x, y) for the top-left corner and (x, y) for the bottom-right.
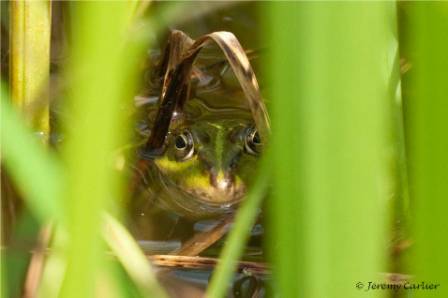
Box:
(145, 31), (270, 159)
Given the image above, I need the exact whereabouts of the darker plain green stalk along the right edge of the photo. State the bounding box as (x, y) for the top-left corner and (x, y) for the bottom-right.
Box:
(400, 2), (448, 297)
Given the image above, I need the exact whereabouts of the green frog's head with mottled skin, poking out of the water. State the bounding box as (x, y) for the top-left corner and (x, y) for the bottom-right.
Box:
(138, 110), (259, 219)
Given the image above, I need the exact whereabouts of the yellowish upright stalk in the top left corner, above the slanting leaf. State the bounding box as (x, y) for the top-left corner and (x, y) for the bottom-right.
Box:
(10, 0), (51, 137)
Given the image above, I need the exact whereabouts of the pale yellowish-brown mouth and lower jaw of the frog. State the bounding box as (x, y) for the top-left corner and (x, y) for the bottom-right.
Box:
(155, 172), (246, 209)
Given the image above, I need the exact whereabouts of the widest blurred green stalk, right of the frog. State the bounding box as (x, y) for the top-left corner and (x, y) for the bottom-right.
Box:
(267, 2), (396, 297)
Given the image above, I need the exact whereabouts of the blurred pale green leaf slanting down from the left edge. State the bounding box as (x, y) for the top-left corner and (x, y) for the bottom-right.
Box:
(1, 91), (64, 221)
